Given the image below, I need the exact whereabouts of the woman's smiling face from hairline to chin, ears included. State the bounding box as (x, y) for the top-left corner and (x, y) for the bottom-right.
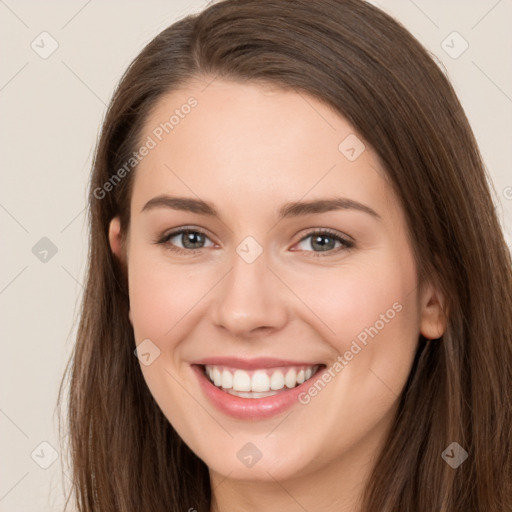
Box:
(110, 79), (442, 481)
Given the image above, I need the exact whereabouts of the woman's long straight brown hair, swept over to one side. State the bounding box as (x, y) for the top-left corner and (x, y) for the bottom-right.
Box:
(58, 0), (512, 512)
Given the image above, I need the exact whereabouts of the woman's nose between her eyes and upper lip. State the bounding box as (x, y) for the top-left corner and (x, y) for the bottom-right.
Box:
(213, 251), (290, 339)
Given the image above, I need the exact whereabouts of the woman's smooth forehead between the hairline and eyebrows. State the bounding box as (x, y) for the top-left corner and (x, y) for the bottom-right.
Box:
(132, 79), (391, 220)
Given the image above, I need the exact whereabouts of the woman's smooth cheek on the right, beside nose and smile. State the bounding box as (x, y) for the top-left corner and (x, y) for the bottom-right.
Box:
(297, 248), (419, 396)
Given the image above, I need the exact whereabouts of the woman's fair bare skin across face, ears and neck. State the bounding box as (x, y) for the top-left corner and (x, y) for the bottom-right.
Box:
(110, 78), (446, 512)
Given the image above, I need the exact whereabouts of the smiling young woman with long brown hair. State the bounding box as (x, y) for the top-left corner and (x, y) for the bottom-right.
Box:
(56, 0), (512, 512)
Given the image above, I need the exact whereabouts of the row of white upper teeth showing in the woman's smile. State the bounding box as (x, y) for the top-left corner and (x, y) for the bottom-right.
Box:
(205, 365), (319, 398)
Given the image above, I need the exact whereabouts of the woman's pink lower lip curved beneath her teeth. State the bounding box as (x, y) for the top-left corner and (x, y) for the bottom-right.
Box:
(192, 365), (323, 420)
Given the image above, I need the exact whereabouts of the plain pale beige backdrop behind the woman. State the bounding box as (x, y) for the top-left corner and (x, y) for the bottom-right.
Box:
(0, 0), (512, 512)
